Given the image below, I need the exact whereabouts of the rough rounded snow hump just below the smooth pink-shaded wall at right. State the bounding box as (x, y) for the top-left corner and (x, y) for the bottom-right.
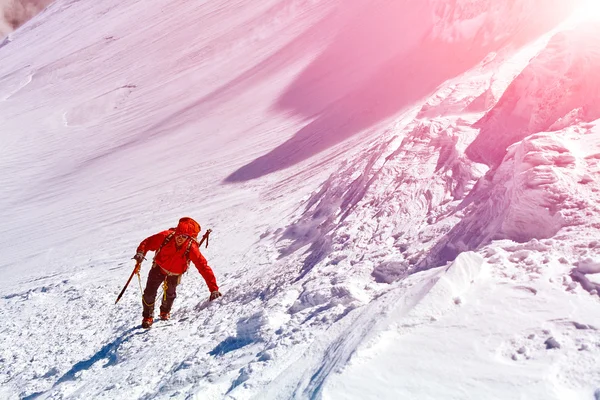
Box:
(420, 131), (592, 268)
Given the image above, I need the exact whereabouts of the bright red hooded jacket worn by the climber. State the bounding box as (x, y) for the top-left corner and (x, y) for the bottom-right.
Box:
(137, 218), (219, 292)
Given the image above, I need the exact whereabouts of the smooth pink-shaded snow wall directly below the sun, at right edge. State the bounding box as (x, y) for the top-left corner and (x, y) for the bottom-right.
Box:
(467, 20), (600, 165)
